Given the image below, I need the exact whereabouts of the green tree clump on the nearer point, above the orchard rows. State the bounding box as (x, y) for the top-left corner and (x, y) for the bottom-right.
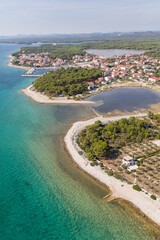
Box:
(78, 117), (159, 161)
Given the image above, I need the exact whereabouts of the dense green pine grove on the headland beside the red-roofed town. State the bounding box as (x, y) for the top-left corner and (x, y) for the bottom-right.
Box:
(33, 68), (102, 97)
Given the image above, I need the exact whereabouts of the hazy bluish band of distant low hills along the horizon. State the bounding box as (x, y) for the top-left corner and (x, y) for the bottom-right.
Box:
(0, 31), (160, 44)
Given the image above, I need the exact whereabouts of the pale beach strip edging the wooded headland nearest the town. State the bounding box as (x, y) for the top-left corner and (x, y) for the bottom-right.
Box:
(21, 85), (95, 104)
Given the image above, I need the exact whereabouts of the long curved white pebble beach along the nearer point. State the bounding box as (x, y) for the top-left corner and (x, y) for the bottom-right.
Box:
(64, 114), (160, 225)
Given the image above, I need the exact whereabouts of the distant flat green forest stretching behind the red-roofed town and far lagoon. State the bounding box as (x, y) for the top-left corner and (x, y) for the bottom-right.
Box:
(12, 40), (160, 60)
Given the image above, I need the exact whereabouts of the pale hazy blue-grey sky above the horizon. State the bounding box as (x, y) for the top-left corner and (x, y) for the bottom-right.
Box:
(0, 0), (160, 35)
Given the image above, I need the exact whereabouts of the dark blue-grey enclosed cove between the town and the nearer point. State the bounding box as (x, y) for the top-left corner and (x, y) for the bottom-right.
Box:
(87, 87), (160, 114)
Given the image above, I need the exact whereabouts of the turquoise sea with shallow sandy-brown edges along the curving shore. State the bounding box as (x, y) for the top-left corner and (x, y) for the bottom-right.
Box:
(0, 44), (160, 240)
